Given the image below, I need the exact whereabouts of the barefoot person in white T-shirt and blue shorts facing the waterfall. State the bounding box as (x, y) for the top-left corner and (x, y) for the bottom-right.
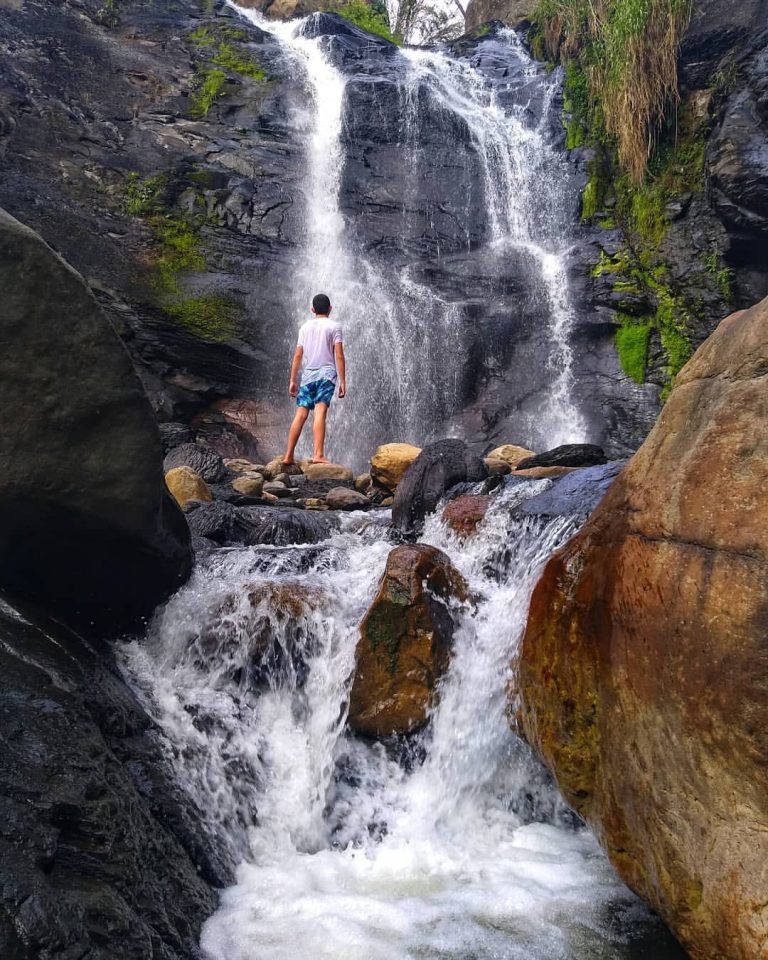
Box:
(283, 293), (347, 466)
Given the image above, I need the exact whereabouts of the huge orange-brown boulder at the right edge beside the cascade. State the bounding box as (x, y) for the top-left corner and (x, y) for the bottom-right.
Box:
(519, 300), (768, 960)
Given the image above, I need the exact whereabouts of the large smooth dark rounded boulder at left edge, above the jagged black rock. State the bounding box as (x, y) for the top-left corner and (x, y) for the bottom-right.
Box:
(0, 211), (192, 631)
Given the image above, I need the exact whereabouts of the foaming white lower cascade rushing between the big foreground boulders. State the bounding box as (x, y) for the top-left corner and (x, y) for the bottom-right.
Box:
(122, 480), (679, 960)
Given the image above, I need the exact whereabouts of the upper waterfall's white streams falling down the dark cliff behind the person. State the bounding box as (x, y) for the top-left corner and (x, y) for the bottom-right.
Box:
(236, 8), (586, 465)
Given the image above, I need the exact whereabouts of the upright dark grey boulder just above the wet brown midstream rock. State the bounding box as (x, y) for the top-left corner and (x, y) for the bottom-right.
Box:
(392, 440), (488, 536)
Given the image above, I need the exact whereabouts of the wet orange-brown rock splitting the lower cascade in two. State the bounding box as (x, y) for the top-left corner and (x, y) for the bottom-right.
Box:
(349, 543), (467, 737)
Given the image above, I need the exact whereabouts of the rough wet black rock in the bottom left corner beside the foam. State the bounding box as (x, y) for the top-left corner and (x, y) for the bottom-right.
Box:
(0, 596), (222, 960)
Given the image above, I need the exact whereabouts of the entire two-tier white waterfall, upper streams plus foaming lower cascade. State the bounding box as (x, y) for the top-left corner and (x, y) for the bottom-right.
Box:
(114, 12), (680, 960)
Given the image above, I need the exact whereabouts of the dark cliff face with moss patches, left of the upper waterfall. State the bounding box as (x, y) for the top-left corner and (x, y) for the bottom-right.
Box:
(0, 0), (304, 424)
